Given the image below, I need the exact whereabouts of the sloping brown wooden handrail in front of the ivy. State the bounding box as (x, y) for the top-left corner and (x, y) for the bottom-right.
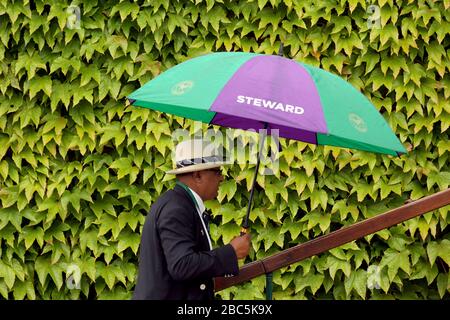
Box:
(215, 188), (450, 291)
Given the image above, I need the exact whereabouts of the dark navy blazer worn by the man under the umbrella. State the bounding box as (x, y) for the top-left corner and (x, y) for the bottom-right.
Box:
(133, 185), (239, 300)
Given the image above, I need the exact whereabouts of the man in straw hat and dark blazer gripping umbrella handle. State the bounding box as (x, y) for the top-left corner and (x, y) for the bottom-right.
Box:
(133, 139), (250, 300)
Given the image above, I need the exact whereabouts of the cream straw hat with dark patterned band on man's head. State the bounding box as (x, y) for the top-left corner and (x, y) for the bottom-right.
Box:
(166, 139), (227, 174)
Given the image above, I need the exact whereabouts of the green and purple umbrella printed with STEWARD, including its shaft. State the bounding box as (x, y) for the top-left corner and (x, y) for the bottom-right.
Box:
(127, 52), (406, 235)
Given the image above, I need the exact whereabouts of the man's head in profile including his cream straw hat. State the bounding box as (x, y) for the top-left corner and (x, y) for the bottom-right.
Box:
(167, 139), (225, 200)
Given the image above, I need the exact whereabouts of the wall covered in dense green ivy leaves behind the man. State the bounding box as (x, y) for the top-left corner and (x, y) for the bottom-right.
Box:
(0, 0), (450, 299)
